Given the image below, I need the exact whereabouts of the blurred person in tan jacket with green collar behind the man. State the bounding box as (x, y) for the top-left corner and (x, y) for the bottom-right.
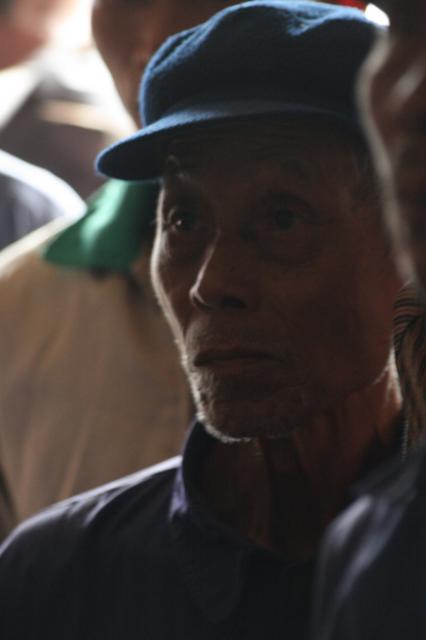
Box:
(0, 0), (246, 537)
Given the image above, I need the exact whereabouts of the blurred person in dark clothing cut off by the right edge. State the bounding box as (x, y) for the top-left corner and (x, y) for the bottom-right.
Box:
(312, 0), (426, 640)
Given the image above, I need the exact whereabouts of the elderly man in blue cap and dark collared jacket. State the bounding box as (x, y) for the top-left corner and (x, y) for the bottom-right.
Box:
(0, 1), (403, 640)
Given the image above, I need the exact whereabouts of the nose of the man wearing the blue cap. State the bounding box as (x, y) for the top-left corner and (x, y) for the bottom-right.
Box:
(189, 239), (259, 311)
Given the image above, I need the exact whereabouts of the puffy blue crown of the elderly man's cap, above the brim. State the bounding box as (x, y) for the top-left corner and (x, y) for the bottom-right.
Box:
(140, 0), (376, 125)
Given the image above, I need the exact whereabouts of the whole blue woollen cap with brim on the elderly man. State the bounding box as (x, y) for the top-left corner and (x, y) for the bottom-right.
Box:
(97, 0), (377, 180)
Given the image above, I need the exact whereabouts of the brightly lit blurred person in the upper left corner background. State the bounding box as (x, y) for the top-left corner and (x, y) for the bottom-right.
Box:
(0, 0), (123, 198)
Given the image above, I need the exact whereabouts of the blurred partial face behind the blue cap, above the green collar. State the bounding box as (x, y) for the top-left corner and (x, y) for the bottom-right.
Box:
(92, 0), (236, 122)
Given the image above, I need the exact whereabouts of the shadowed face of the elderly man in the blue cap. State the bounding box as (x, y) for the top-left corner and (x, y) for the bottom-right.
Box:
(152, 124), (399, 439)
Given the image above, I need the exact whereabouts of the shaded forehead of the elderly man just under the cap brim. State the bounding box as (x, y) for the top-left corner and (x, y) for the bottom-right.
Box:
(162, 120), (361, 182)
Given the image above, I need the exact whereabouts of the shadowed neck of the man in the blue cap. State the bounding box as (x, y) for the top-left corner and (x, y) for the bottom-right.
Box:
(202, 371), (401, 562)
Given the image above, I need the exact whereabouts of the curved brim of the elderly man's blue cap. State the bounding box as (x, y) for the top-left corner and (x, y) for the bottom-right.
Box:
(96, 99), (357, 180)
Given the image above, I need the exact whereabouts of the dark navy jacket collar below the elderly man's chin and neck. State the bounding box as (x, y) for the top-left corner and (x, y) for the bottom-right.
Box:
(169, 423), (302, 623)
